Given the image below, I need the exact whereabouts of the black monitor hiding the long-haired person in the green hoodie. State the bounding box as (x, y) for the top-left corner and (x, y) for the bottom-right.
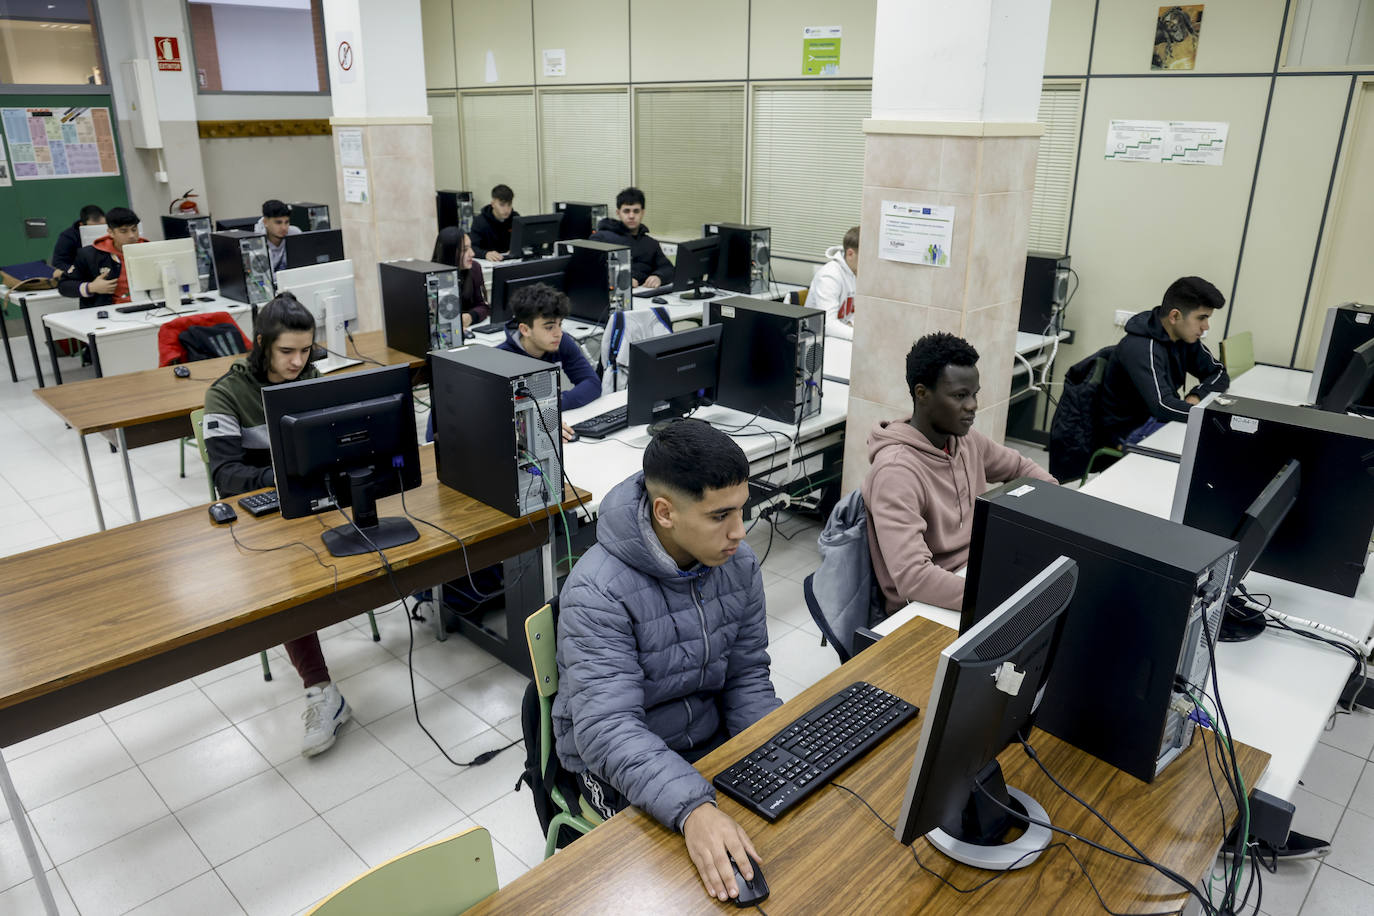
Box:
(262, 365), (420, 556)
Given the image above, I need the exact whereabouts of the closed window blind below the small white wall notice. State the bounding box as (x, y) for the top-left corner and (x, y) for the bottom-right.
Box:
(539, 89), (629, 213)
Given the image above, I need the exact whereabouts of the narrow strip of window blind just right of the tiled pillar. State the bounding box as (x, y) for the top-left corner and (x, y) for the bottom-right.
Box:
(1026, 84), (1083, 254)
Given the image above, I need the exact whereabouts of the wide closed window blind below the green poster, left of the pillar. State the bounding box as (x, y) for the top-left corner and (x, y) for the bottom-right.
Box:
(749, 87), (872, 261)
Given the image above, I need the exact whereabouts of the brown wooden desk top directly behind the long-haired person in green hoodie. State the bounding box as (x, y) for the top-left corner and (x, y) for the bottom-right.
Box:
(33, 331), (414, 435)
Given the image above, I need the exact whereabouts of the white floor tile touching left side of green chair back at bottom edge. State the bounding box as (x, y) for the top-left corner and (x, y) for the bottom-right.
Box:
(217, 817), (367, 916)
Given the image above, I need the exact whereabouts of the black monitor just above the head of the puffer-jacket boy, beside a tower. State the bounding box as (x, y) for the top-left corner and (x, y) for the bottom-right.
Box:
(628, 324), (721, 426)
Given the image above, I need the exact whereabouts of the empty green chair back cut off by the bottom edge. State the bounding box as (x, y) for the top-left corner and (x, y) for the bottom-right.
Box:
(309, 827), (499, 916)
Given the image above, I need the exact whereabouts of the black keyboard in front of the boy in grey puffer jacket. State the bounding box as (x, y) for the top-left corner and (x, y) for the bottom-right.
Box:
(713, 681), (919, 821)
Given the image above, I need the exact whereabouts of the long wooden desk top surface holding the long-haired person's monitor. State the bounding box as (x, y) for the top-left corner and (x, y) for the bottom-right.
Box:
(0, 448), (585, 711)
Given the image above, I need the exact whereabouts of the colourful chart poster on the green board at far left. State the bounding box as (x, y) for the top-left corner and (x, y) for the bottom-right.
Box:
(0, 108), (120, 181)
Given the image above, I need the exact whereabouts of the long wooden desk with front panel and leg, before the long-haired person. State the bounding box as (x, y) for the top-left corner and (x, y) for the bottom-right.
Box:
(0, 448), (588, 913)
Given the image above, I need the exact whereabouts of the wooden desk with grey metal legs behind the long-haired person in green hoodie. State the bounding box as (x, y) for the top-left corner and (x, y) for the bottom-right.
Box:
(34, 329), (425, 531)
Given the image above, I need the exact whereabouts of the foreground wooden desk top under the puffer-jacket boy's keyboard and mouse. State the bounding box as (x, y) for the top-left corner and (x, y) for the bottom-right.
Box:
(469, 618), (1268, 916)
